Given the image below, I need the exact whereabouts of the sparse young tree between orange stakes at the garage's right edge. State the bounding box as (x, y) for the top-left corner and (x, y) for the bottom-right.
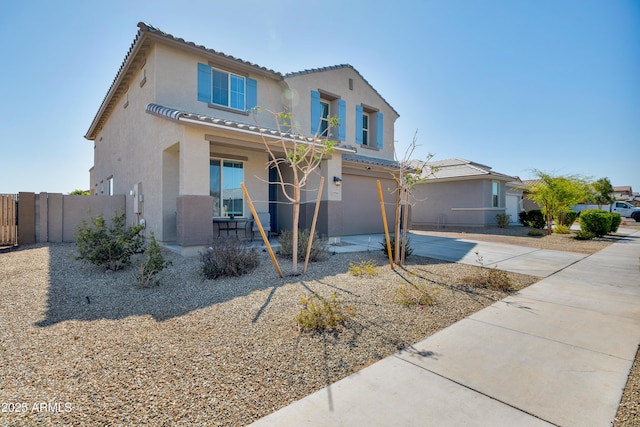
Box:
(390, 131), (437, 265)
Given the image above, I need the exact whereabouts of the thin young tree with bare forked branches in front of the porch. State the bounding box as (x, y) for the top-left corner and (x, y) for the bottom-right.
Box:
(253, 110), (338, 275)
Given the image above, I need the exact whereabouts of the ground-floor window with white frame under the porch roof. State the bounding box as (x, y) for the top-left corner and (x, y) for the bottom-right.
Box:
(209, 159), (244, 217)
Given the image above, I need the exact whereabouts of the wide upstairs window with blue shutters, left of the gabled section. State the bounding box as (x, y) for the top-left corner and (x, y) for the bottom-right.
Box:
(198, 64), (258, 111)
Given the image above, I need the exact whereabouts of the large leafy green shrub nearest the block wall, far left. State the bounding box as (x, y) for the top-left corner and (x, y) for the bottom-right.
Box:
(75, 211), (144, 271)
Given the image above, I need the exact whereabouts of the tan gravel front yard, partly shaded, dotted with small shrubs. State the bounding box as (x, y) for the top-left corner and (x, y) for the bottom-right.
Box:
(0, 224), (640, 427)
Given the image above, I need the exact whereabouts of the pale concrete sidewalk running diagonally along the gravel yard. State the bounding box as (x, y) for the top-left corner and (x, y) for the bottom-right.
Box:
(253, 232), (640, 426)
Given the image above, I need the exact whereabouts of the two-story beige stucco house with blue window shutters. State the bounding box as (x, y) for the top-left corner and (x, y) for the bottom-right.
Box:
(85, 23), (399, 251)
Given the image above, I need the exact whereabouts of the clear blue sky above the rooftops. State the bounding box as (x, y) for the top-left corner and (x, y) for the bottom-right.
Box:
(0, 0), (640, 193)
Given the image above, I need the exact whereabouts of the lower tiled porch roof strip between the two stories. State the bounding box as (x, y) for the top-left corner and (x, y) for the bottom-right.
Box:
(145, 103), (355, 152)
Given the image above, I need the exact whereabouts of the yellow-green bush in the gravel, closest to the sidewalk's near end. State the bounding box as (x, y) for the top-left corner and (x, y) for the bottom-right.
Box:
(296, 292), (356, 332)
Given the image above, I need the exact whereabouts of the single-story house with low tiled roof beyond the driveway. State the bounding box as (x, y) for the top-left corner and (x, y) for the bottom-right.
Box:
(411, 159), (522, 228)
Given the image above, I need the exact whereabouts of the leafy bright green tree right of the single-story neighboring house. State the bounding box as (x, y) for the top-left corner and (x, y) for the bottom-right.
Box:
(527, 170), (590, 235)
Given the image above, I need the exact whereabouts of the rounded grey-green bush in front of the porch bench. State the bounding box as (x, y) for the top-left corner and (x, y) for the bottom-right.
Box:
(200, 237), (260, 279)
